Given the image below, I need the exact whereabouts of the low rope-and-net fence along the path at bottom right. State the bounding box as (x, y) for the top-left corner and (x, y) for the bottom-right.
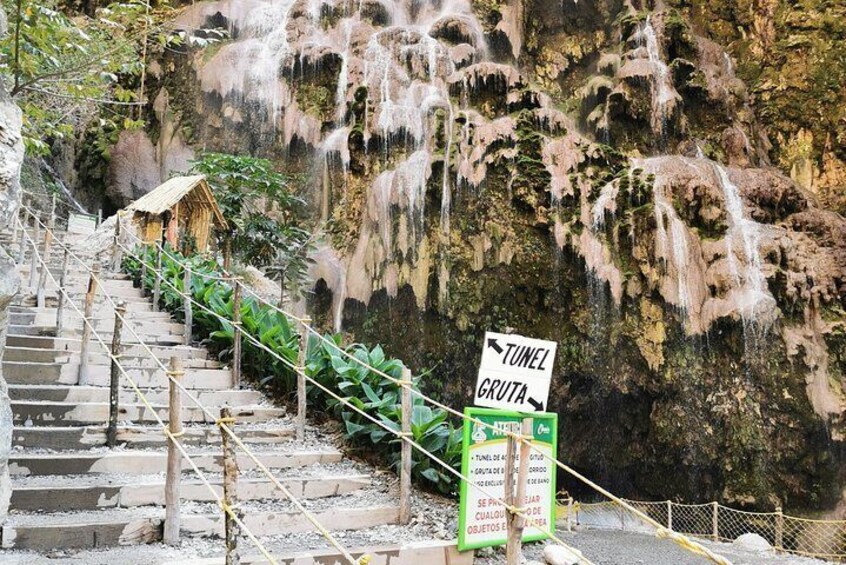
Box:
(560, 500), (846, 561)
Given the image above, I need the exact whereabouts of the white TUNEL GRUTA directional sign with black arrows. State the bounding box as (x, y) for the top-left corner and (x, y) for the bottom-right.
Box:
(473, 332), (558, 412)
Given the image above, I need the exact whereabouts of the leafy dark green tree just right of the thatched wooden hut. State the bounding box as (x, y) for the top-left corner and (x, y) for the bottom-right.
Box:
(193, 153), (311, 298)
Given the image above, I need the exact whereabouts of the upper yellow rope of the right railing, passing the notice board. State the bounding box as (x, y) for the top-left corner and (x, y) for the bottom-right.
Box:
(114, 230), (731, 565)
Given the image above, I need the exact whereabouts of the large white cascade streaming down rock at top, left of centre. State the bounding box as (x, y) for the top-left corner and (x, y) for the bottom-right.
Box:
(181, 0), (496, 324)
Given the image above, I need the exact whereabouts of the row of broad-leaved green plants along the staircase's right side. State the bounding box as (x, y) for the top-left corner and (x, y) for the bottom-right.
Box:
(123, 248), (461, 493)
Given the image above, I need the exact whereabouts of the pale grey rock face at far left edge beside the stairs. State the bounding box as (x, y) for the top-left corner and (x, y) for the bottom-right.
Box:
(0, 9), (24, 521)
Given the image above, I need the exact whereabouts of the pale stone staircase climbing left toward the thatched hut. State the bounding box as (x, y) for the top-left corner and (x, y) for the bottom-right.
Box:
(0, 218), (472, 564)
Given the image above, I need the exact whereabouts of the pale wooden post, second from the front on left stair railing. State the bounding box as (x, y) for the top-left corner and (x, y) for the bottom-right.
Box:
(162, 355), (185, 545)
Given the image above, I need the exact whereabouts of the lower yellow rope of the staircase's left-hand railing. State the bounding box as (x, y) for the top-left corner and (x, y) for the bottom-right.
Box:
(16, 219), (278, 564)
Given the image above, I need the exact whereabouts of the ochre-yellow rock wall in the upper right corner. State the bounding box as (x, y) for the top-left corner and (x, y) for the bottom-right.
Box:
(670, 0), (846, 214)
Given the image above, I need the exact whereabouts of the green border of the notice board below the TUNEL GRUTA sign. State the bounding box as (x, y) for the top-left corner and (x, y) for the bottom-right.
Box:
(458, 406), (558, 551)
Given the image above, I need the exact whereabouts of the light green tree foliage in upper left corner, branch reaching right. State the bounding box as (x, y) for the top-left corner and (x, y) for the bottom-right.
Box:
(0, 0), (221, 157)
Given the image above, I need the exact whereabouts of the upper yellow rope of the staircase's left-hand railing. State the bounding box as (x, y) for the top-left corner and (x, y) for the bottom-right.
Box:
(14, 207), (358, 565)
